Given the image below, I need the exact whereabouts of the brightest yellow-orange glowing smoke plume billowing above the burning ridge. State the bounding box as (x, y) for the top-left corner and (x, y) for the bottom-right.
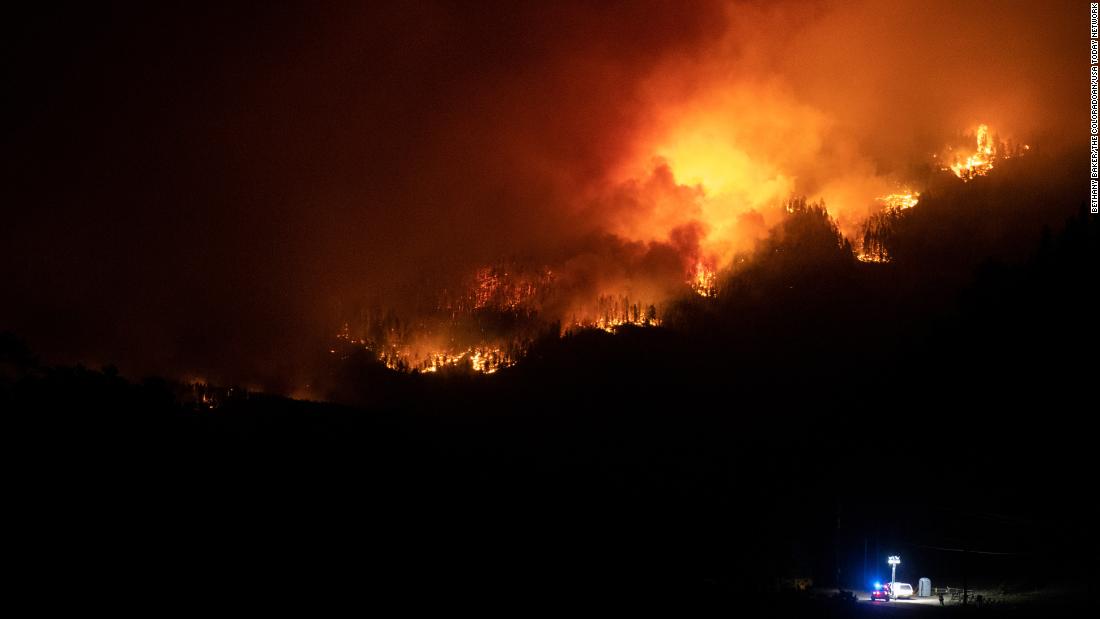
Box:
(612, 80), (828, 269)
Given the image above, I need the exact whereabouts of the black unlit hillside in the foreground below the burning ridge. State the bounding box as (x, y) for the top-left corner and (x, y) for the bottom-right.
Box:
(0, 200), (1097, 617)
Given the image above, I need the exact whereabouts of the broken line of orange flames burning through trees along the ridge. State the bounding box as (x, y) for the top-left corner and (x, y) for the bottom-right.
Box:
(330, 124), (1031, 374)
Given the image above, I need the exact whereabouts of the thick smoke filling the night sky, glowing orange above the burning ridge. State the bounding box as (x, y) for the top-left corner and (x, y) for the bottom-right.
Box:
(0, 1), (1084, 391)
